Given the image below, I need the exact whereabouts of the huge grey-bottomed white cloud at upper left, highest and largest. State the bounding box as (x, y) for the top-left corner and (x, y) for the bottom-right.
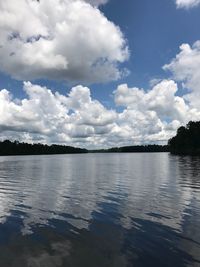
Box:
(0, 0), (129, 83)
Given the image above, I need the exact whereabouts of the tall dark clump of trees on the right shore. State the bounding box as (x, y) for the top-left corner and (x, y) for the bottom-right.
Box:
(168, 121), (200, 155)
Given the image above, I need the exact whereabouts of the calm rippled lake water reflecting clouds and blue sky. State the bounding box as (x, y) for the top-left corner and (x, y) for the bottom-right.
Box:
(0, 153), (200, 267)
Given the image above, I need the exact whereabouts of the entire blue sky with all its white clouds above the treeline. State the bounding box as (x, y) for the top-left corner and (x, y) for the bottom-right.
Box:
(0, 0), (200, 149)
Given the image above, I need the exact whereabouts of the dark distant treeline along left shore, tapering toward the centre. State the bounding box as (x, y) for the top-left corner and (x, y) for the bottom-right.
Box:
(0, 140), (88, 155)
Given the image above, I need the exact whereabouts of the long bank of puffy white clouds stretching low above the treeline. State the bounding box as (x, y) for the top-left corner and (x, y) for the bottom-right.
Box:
(0, 80), (200, 148)
